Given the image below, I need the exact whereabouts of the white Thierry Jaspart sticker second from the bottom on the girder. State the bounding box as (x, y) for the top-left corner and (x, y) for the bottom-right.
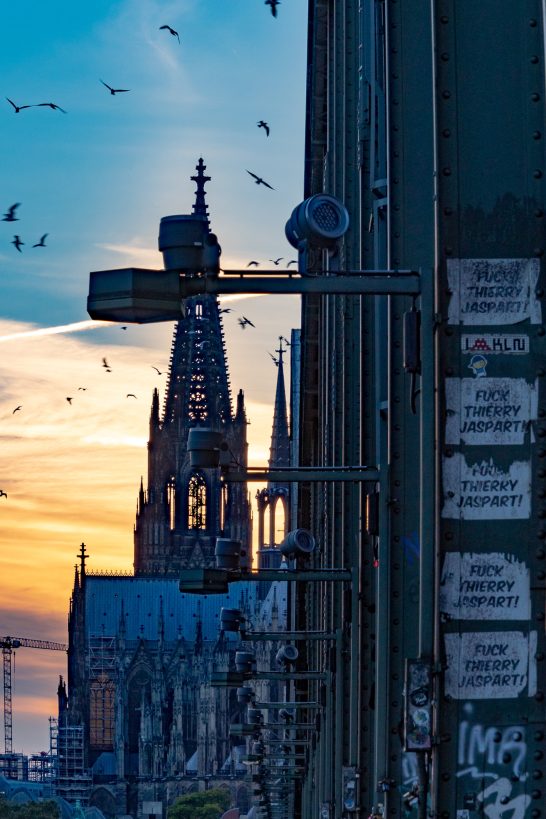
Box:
(440, 552), (531, 620)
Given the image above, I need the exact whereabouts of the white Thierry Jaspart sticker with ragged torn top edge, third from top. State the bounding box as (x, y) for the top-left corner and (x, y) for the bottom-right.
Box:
(442, 452), (531, 520)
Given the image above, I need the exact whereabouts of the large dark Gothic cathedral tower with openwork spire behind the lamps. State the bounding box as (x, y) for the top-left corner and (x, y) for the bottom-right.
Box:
(134, 159), (251, 575)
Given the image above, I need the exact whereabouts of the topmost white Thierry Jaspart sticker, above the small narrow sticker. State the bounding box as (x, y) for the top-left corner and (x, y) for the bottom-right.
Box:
(447, 259), (542, 326)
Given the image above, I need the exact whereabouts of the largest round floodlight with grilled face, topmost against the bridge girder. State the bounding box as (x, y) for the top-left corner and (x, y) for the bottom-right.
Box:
(285, 193), (349, 250)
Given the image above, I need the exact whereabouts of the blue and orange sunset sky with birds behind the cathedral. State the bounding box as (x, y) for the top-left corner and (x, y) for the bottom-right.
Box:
(0, 0), (307, 753)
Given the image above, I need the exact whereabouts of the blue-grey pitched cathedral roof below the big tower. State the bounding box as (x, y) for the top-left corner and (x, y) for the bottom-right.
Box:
(85, 575), (257, 642)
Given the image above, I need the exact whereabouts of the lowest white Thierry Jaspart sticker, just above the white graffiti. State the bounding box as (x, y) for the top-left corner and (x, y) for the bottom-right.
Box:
(444, 631), (537, 700)
